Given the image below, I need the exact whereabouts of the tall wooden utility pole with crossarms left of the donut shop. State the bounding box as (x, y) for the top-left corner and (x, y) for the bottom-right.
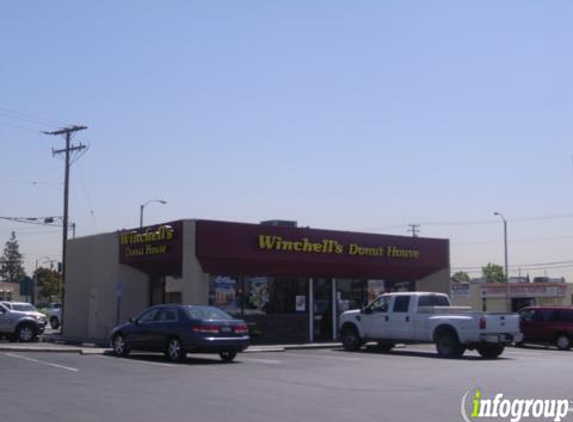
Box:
(44, 125), (87, 334)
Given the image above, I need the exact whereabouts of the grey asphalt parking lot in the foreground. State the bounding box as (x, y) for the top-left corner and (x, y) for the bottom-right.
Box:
(0, 345), (573, 422)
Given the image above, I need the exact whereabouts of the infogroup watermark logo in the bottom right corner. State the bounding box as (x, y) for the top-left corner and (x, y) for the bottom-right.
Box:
(460, 388), (573, 422)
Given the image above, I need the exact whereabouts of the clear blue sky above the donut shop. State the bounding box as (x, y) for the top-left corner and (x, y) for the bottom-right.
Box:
(0, 0), (573, 281)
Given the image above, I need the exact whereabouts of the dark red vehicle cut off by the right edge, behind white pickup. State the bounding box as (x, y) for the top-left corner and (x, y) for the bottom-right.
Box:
(518, 306), (573, 350)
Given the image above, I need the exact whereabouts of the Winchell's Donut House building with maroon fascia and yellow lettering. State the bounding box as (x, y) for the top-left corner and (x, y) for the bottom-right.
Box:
(63, 220), (450, 344)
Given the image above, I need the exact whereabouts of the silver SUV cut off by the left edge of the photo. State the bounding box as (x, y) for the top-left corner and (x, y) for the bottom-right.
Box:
(0, 302), (46, 342)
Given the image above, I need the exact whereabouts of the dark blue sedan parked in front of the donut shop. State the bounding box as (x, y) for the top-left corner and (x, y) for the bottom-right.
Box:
(110, 304), (249, 362)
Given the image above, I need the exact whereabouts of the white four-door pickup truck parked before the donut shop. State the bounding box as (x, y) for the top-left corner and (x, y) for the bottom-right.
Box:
(339, 292), (523, 359)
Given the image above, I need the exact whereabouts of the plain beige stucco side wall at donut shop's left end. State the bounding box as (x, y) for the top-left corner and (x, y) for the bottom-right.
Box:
(63, 233), (149, 342)
